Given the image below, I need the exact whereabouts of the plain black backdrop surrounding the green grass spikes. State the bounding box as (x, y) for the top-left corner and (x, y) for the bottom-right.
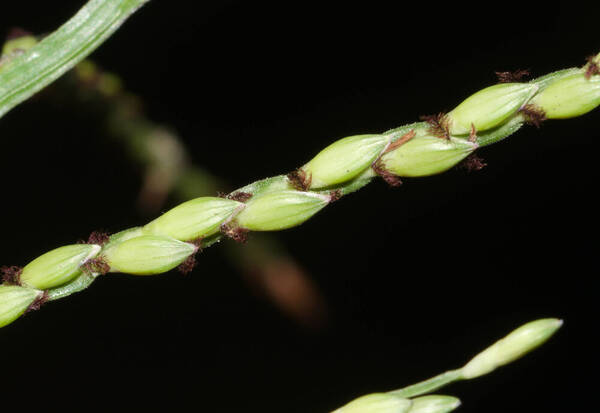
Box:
(0, 0), (600, 413)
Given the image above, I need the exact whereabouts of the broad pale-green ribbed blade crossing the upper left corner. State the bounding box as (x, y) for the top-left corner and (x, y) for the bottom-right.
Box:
(0, 0), (148, 117)
